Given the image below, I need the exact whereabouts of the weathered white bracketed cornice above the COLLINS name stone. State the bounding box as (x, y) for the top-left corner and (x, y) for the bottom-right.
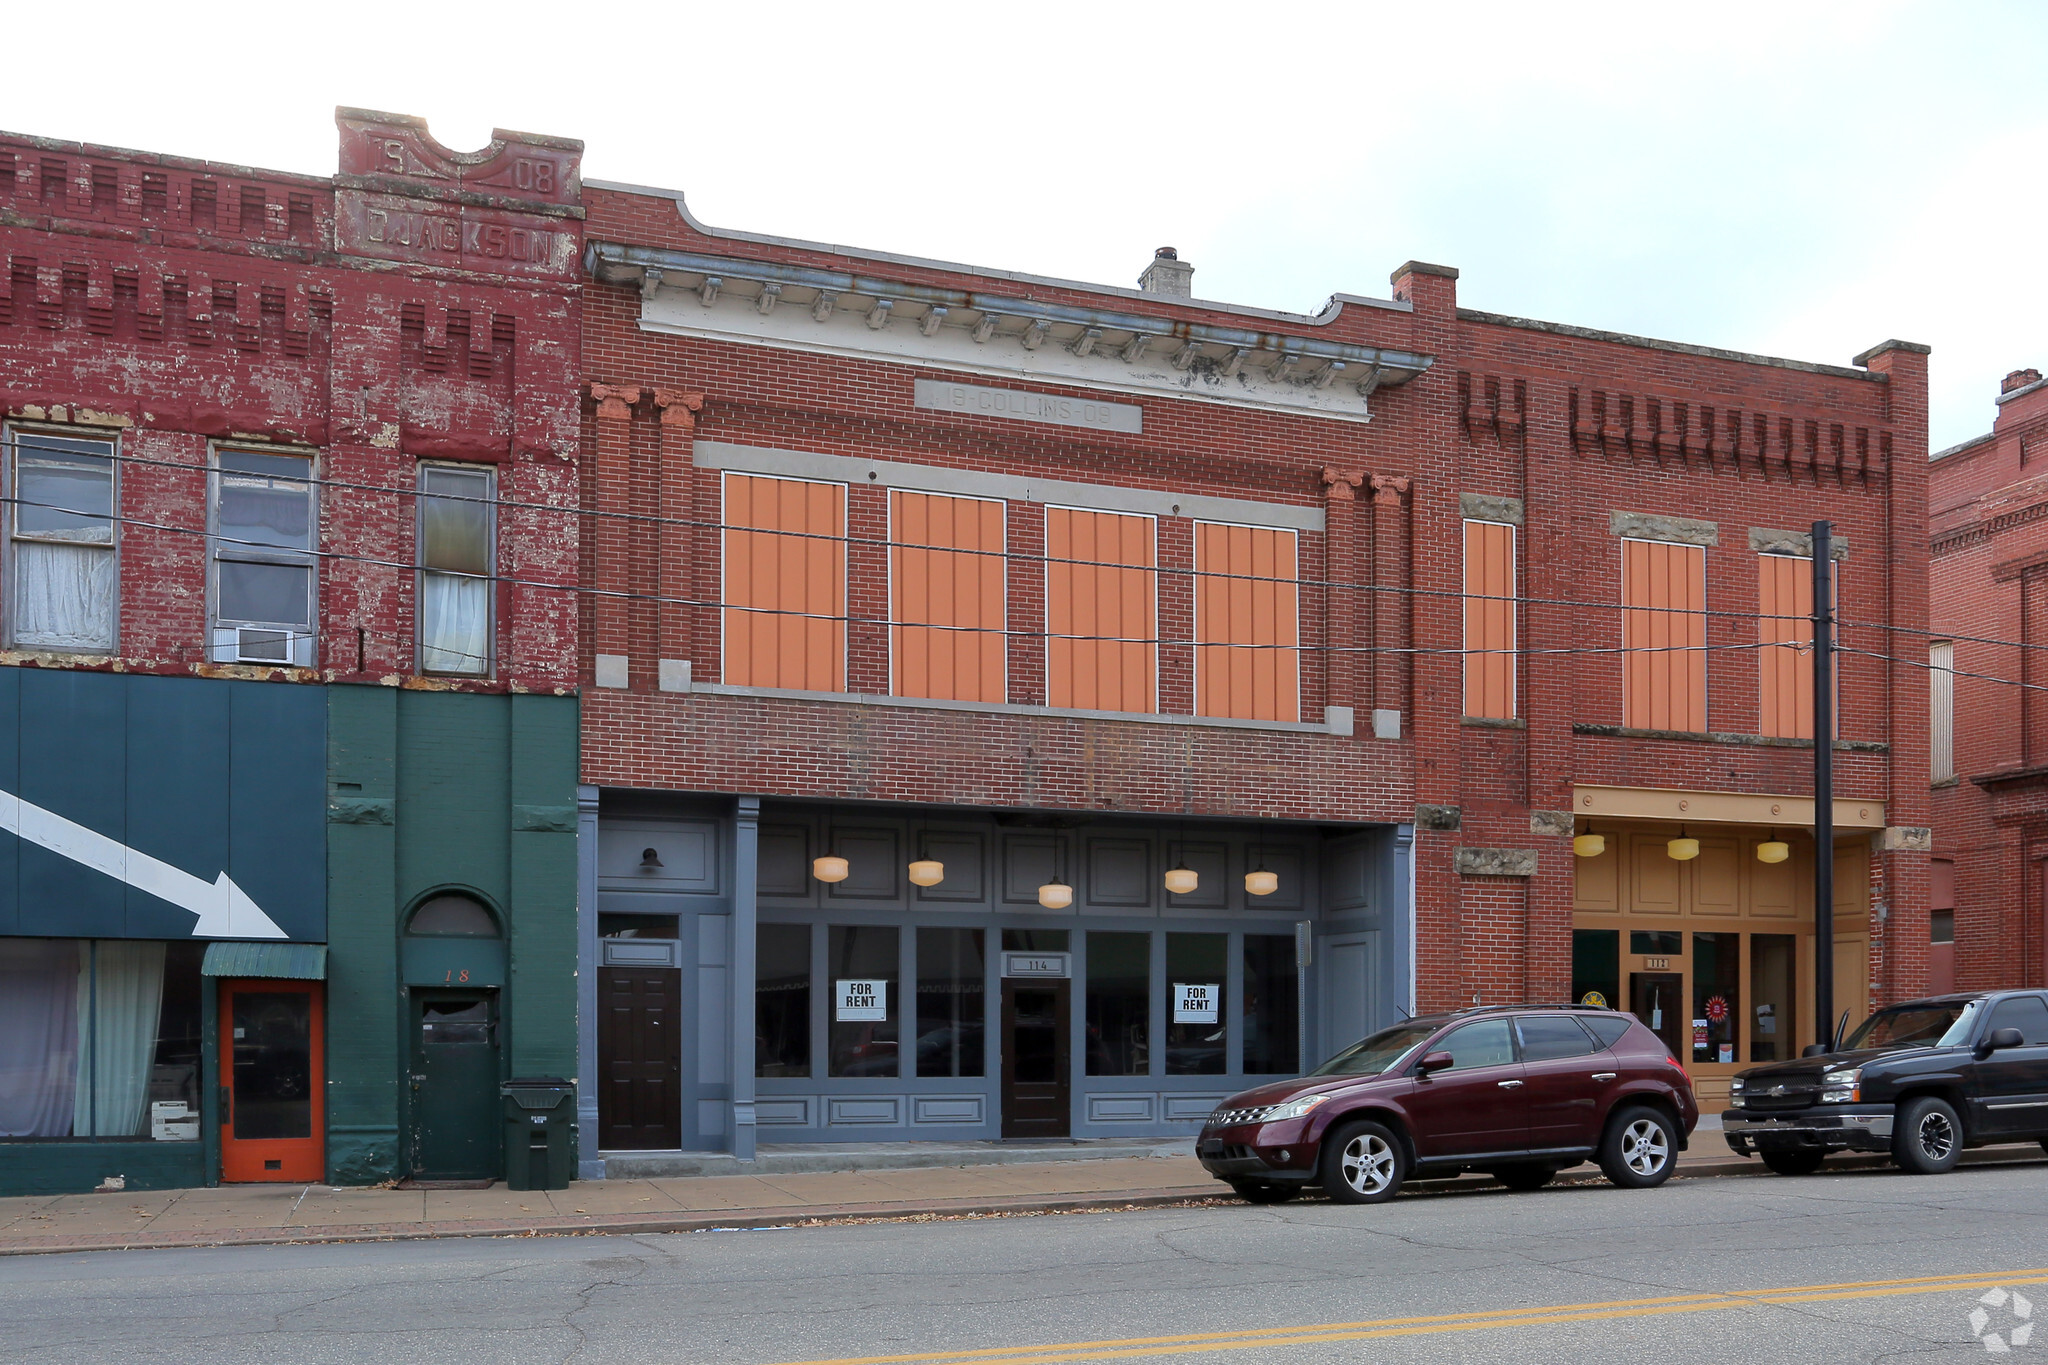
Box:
(586, 241), (1432, 422)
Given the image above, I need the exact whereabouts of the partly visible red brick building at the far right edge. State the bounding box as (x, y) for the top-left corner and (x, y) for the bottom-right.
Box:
(1927, 370), (2048, 990)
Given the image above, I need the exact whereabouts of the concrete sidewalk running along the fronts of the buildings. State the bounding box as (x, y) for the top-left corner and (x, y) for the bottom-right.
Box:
(0, 1134), (2048, 1254)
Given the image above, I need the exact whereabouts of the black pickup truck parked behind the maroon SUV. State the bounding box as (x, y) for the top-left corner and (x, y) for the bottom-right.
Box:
(1720, 990), (2048, 1175)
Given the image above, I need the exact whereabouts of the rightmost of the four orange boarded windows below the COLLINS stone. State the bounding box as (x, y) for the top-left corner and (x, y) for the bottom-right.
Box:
(1194, 522), (1300, 720)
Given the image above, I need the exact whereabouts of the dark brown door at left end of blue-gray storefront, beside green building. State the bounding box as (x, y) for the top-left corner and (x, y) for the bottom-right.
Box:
(598, 966), (682, 1152)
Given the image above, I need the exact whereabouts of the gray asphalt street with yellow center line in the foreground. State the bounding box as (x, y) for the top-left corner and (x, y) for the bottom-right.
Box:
(0, 1162), (2048, 1365)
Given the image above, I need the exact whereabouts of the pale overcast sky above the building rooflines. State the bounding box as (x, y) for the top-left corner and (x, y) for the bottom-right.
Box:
(0, 0), (2048, 450)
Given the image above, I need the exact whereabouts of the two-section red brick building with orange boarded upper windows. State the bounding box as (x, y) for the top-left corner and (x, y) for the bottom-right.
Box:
(582, 184), (1927, 1173)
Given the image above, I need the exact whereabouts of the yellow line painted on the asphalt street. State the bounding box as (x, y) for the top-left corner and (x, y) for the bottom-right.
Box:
(765, 1269), (2048, 1365)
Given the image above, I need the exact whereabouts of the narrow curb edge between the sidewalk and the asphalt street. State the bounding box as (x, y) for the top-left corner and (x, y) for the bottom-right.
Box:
(0, 1144), (2048, 1257)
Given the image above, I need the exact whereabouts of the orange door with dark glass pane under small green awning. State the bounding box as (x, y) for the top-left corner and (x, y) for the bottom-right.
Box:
(221, 980), (326, 1183)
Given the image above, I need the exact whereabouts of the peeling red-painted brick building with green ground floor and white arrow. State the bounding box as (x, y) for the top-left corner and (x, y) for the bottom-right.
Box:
(0, 111), (582, 1191)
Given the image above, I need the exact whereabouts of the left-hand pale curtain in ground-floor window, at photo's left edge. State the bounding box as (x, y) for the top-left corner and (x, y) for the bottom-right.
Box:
(0, 939), (80, 1138)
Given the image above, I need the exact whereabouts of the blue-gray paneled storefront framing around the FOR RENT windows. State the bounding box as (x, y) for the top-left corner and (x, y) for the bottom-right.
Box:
(578, 788), (1413, 1179)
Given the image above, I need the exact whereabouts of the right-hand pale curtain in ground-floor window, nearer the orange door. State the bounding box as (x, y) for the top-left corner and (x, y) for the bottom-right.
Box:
(72, 939), (164, 1138)
